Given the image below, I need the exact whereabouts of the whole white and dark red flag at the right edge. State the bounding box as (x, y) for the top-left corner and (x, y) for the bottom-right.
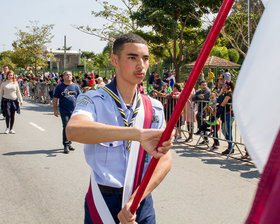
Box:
(233, 0), (280, 221)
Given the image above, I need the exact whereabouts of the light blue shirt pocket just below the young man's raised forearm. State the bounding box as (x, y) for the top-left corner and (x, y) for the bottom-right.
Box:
(95, 141), (123, 165)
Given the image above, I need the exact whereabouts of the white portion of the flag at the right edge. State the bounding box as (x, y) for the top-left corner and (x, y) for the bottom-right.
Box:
(233, 0), (280, 172)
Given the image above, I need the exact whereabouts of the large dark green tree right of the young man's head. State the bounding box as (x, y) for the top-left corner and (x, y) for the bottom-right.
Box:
(133, 0), (222, 80)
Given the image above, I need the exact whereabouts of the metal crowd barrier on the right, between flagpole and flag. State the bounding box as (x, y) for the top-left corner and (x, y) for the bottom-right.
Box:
(153, 95), (245, 158)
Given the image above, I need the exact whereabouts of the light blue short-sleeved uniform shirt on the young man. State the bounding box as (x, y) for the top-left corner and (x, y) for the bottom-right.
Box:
(72, 89), (165, 188)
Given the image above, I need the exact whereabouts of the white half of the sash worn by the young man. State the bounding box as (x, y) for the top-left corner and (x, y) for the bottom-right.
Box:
(91, 97), (145, 224)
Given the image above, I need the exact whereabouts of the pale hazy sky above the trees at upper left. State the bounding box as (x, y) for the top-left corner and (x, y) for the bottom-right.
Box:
(0, 0), (119, 53)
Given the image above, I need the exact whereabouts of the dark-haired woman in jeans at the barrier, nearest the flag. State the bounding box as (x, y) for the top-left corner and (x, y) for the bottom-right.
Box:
(220, 81), (234, 155)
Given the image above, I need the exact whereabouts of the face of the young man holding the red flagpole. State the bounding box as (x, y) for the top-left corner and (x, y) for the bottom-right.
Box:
(111, 43), (149, 85)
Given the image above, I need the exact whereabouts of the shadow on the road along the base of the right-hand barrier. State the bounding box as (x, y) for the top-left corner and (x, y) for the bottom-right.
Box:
(173, 145), (260, 179)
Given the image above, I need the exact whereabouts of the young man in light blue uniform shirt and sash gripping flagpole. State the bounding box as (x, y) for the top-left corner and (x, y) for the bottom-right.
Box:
(66, 33), (174, 224)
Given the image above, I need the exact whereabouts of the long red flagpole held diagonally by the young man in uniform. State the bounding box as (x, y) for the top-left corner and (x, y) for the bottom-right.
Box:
(130, 0), (234, 214)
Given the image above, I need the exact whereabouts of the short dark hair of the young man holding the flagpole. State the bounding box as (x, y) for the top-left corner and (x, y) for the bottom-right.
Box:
(113, 33), (148, 56)
